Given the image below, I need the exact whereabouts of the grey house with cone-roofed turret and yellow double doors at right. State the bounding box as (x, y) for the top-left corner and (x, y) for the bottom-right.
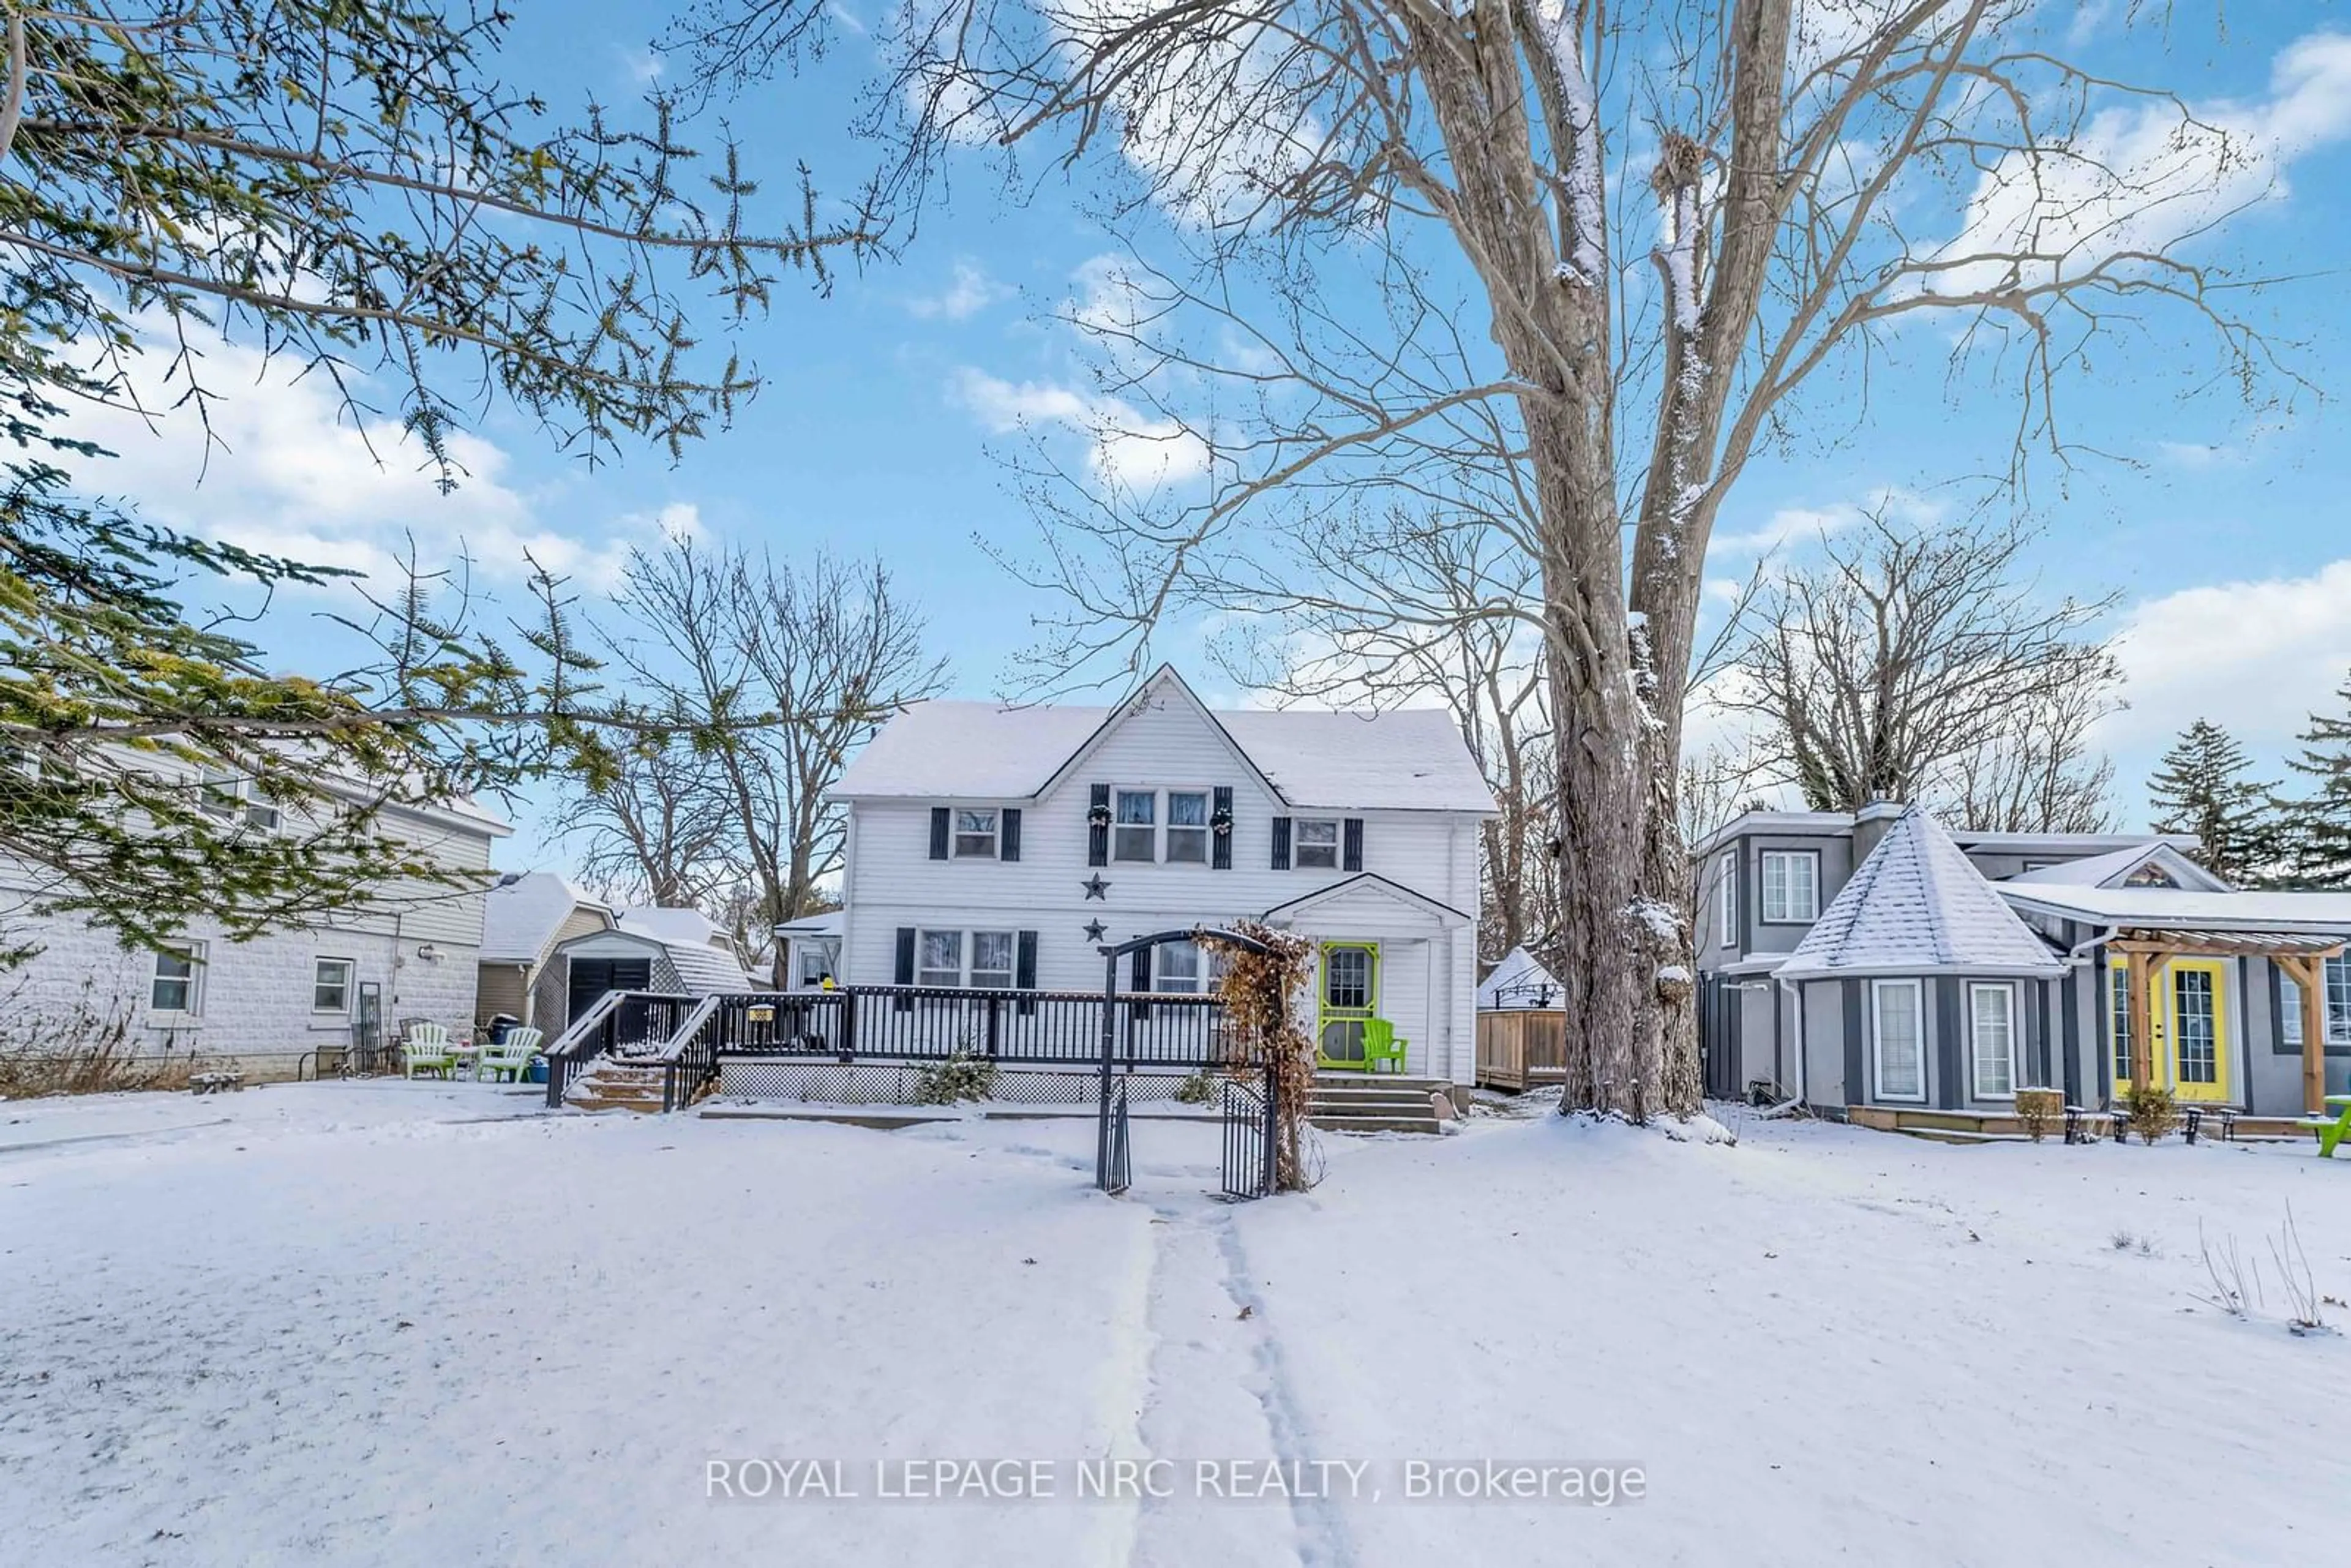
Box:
(1695, 804), (2351, 1126)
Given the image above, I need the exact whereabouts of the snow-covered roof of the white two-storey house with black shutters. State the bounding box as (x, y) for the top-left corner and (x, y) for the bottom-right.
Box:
(832, 667), (1493, 813)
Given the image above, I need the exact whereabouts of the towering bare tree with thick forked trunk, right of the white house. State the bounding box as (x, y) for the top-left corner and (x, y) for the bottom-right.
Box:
(686, 0), (2294, 1119)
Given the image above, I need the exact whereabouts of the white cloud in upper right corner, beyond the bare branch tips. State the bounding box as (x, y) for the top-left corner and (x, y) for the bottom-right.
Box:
(1928, 33), (2351, 294)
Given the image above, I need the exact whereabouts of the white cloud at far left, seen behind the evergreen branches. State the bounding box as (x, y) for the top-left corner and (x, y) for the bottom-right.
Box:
(57, 322), (698, 590)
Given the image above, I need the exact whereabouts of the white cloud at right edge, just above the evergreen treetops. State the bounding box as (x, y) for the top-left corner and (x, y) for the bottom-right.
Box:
(2104, 560), (2351, 755)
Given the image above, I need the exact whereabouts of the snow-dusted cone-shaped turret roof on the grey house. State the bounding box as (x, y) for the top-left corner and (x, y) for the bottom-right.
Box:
(1775, 806), (2064, 980)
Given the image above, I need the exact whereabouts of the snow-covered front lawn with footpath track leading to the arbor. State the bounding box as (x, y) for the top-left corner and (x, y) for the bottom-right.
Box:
(0, 1084), (2351, 1568)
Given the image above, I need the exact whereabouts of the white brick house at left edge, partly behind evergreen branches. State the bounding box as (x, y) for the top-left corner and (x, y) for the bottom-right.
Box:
(0, 804), (512, 1079)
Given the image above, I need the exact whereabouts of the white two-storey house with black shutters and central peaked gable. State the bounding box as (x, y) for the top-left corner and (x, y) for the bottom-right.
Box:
(813, 667), (1493, 1084)
